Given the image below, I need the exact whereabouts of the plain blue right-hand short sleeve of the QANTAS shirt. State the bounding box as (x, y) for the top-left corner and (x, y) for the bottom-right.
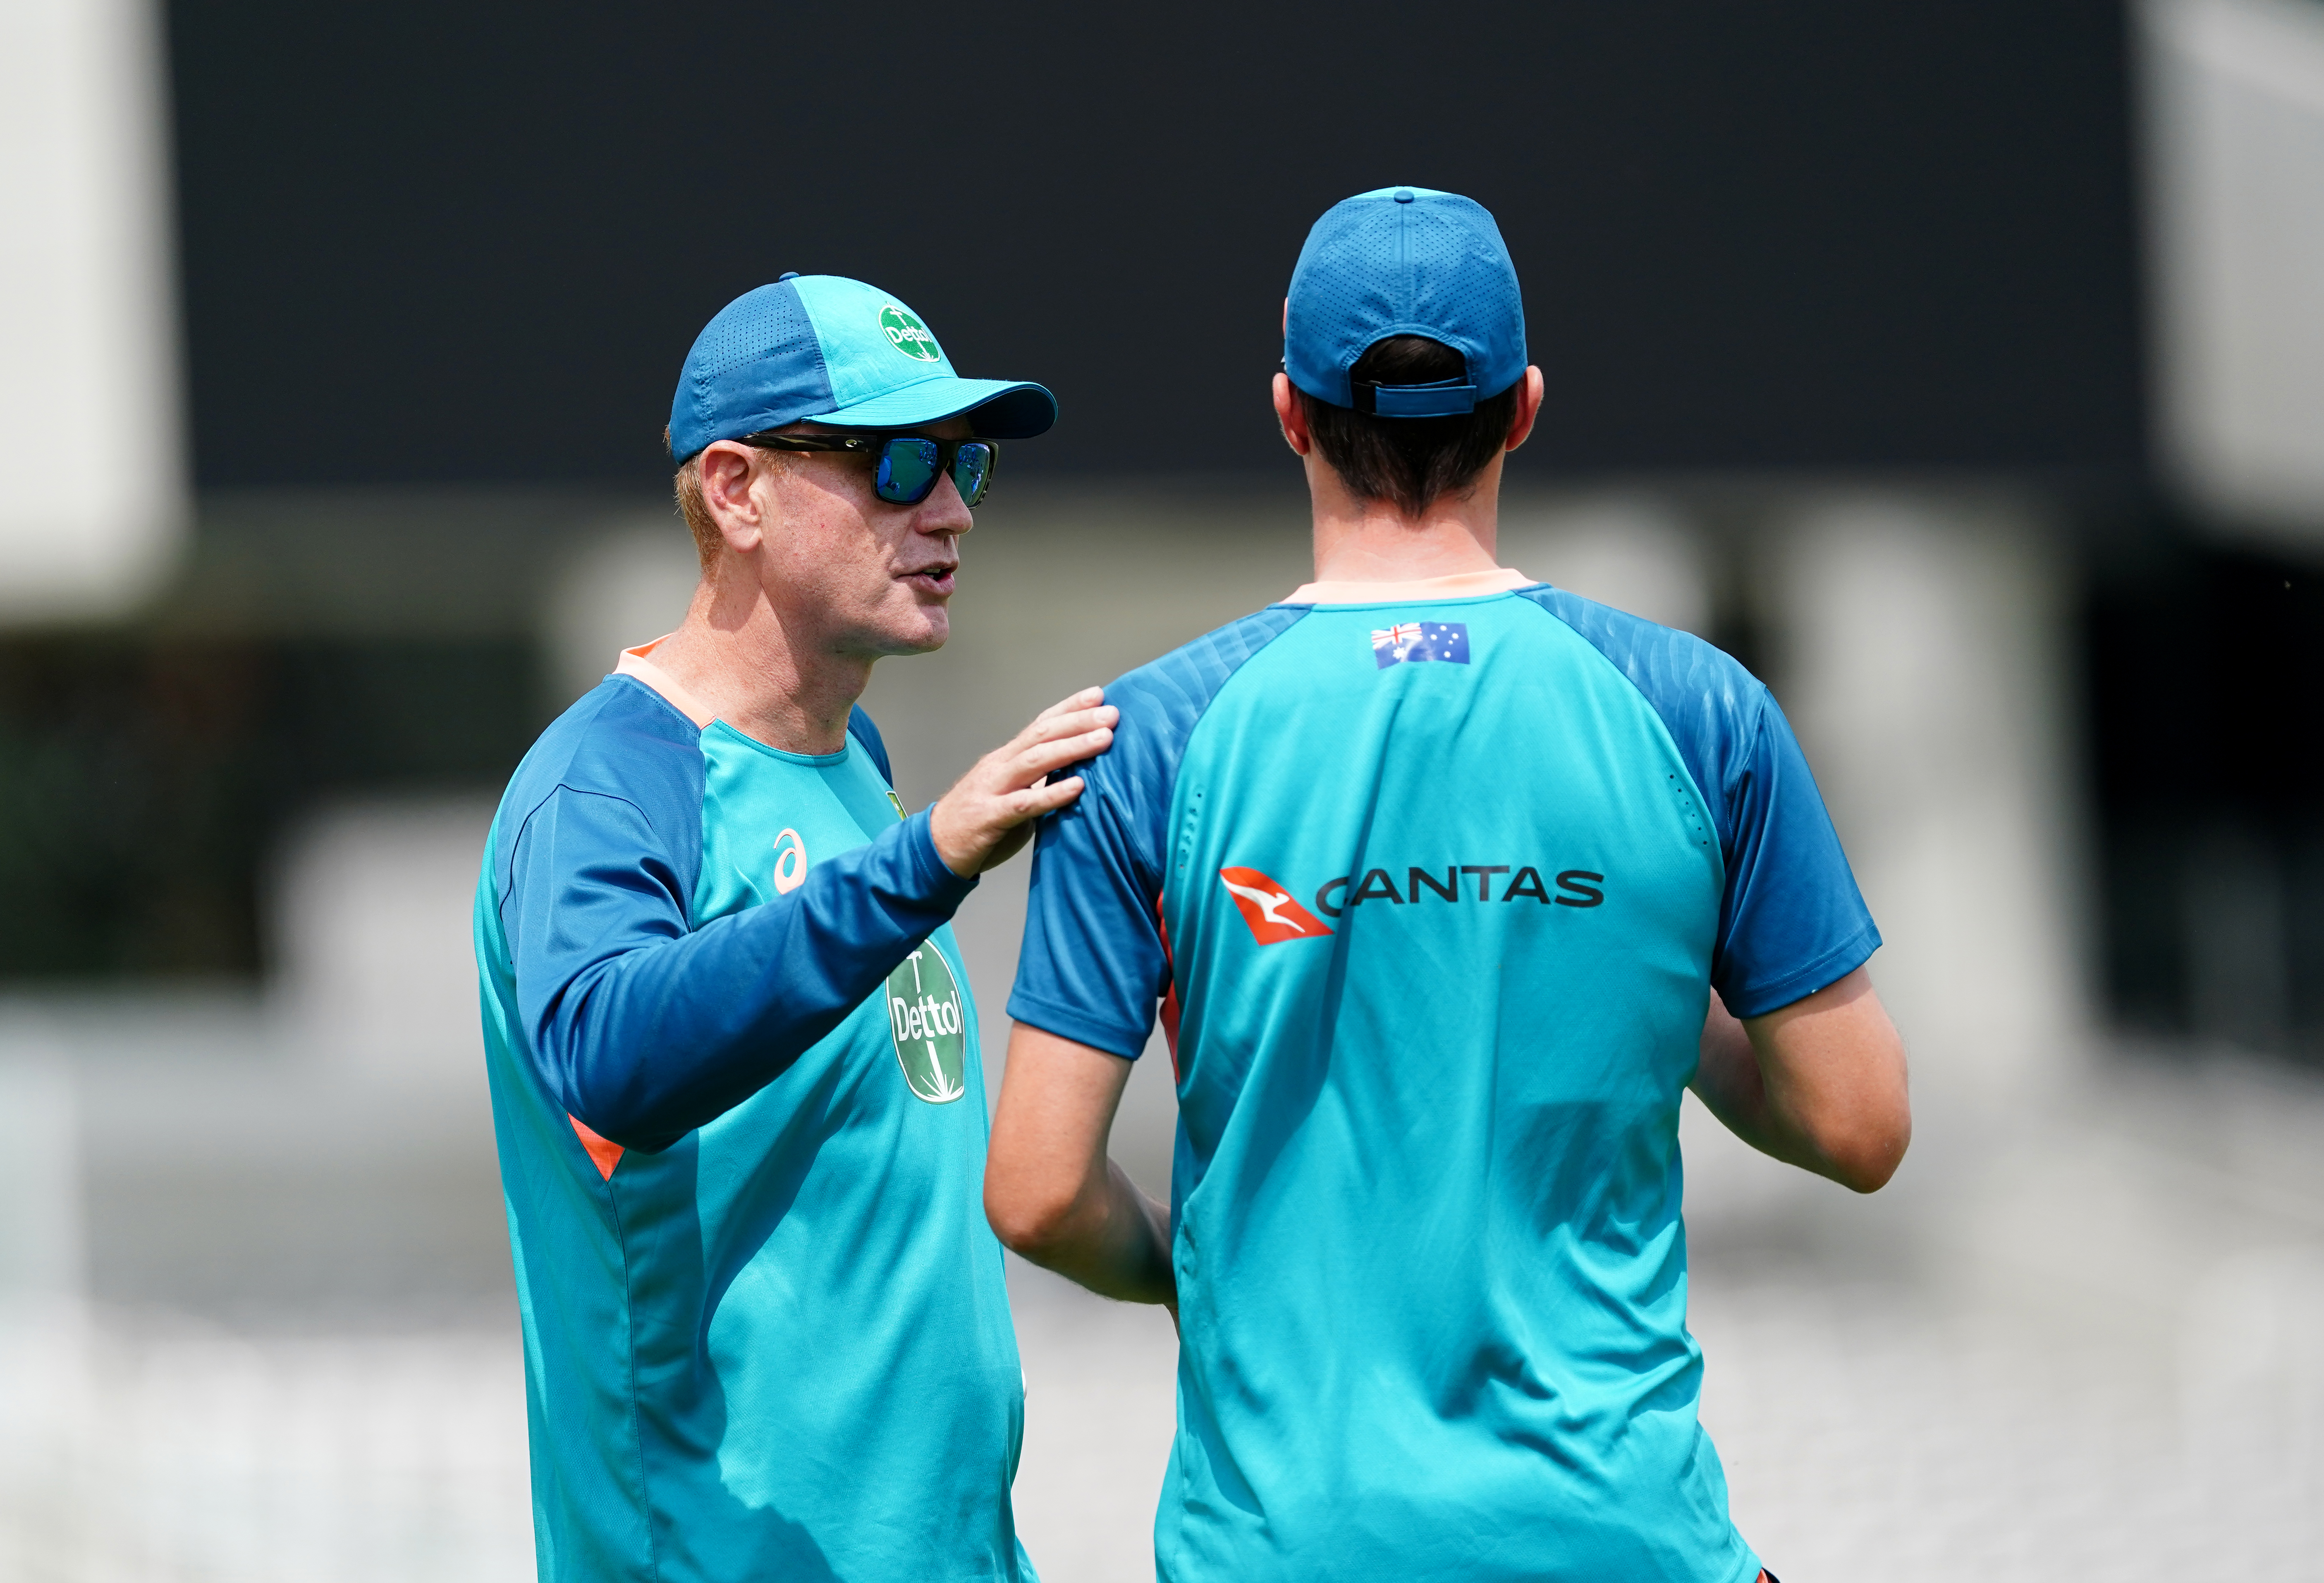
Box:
(1710, 681), (1880, 1016)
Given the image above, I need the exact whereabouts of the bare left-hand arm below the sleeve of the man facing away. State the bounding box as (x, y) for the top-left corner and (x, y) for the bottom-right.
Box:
(985, 1023), (1178, 1313)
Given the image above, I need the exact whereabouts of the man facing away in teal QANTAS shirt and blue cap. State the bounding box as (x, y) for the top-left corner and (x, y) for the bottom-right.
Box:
(985, 188), (1910, 1583)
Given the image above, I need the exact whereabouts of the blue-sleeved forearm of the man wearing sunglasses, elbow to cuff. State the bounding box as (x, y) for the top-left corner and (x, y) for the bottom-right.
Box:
(518, 818), (974, 1148)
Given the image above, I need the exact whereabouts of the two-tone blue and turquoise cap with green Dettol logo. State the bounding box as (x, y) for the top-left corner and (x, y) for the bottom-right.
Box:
(669, 272), (1057, 462)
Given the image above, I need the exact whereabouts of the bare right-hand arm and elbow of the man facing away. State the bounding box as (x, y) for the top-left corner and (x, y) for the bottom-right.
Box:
(1690, 967), (1913, 1193)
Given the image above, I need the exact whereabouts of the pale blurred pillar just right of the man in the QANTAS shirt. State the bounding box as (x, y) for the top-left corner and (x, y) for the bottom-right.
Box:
(1759, 493), (2089, 1104)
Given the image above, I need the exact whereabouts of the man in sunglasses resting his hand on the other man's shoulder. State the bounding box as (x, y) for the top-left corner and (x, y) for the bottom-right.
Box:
(476, 274), (1113, 1583)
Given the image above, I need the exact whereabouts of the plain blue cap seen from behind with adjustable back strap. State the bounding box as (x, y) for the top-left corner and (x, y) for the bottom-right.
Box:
(1283, 186), (1525, 419)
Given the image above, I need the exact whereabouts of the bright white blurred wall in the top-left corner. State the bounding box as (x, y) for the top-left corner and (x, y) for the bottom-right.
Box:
(0, 0), (186, 623)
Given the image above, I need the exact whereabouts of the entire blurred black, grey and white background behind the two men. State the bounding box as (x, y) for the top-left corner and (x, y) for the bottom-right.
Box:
(0, 0), (2324, 1583)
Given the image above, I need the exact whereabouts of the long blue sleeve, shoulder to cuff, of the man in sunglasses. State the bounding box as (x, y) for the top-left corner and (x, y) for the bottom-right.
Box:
(500, 697), (976, 1151)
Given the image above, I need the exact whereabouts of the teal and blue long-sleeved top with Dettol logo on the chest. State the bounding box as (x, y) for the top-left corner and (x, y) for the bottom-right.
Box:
(474, 653), (1032, 1583)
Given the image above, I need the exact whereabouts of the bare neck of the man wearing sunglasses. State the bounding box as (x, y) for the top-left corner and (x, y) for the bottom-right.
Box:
(653, 579), (872, 753)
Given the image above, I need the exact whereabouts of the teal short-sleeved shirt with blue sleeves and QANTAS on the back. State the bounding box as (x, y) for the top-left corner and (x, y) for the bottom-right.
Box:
(1011, 574), (1878, 1583)
